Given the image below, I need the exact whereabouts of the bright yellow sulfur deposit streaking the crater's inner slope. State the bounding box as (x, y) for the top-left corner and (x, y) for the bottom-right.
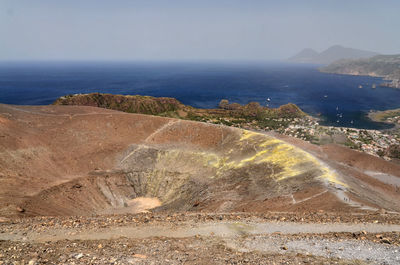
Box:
(156, 131), (346, 187)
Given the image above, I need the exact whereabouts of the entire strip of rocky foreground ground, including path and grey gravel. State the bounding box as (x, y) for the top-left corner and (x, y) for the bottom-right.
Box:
(0, 212), (400, 264)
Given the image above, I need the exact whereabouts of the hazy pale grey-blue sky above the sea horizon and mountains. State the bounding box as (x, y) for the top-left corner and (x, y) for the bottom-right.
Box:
(0, 0), (400, 60)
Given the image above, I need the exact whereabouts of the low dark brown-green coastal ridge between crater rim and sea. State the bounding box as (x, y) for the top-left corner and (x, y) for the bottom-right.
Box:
(53, 93), (306, 125)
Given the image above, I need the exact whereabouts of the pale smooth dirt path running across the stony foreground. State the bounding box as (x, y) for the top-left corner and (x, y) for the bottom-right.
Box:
(0, 222), (400, 242)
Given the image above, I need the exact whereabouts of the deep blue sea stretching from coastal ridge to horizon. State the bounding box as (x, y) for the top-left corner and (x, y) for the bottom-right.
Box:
(0, 62), (400, 129)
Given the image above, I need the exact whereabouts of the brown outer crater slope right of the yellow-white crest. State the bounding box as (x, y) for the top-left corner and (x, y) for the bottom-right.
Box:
(270, 133), (400, 211)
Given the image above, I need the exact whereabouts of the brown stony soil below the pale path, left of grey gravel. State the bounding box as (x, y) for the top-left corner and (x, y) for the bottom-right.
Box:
(0, 234), (366, 265)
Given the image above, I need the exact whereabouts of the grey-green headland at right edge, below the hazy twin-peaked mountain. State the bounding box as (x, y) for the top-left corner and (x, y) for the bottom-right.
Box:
(320, 54), (400, 88)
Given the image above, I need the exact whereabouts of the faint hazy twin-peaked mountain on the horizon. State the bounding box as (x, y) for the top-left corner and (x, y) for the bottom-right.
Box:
(288, 45), (378, 64)
